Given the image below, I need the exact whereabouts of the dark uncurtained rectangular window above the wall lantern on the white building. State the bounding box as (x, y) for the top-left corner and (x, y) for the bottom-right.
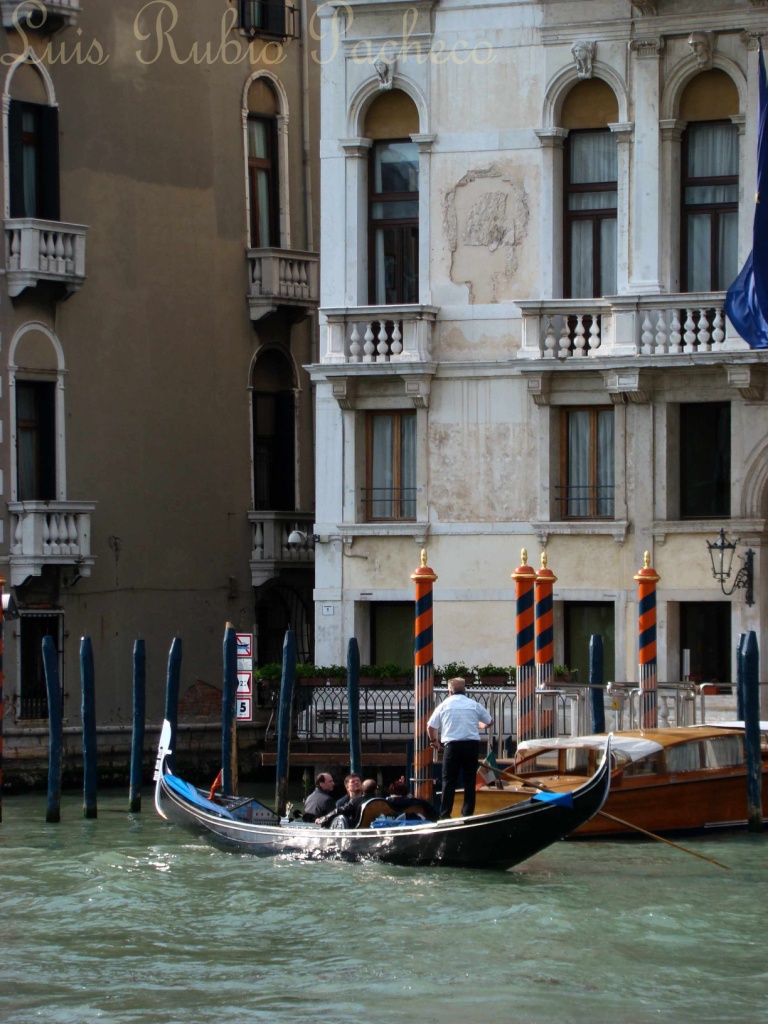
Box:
(680, 401), (731, 519)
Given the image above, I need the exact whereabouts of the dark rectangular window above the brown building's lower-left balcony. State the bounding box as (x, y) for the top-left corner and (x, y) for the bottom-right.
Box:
(15, 380), (56, 502)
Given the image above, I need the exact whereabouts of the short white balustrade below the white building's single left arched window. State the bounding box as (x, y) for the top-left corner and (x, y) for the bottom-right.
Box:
(321, 305), (438, 364)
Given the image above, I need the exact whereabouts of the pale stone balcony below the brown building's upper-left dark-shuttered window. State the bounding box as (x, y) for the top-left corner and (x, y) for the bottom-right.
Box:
(5, 217), (87, 298)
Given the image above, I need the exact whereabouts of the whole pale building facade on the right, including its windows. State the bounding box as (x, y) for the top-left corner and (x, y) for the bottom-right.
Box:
(311, 0), (768, 681)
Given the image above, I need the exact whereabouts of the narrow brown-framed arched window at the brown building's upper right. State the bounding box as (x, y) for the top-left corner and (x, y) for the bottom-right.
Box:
(247, 78), (281, 249)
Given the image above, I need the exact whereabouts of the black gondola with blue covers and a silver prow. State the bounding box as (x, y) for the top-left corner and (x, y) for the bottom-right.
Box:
(155, 722), (610, 868)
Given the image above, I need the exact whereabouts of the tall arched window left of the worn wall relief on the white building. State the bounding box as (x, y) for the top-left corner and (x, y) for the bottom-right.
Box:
(365, 89), (419, 306)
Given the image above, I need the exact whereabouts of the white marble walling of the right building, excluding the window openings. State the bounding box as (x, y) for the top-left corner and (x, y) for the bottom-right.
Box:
(311, 0), (768, 680)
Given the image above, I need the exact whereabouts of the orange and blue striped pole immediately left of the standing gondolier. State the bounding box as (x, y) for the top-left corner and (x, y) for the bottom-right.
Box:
(411, 550), (437, 801)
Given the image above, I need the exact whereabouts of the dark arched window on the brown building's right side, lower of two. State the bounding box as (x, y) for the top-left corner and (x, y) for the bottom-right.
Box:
(256, 348), (296, 512)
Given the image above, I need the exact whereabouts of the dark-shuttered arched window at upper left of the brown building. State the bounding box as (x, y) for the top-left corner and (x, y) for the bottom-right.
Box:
(6, 60), (59, 220)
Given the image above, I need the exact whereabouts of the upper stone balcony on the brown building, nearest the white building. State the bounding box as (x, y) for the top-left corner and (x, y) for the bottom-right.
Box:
(247, 249), (319, 321)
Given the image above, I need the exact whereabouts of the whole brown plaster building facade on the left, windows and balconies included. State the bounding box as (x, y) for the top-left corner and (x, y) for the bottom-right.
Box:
(0, 0), (319, 757)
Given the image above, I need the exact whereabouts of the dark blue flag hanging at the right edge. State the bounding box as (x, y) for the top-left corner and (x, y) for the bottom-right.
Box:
(725, 45), (768, 348)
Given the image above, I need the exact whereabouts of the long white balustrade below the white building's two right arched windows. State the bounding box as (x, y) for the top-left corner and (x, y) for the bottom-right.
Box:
(517, 292), (748, 359)
